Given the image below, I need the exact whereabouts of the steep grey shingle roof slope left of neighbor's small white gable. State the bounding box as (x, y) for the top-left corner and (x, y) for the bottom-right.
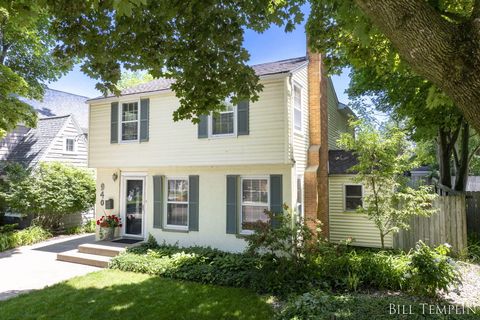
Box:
(6, 115), (69, 167)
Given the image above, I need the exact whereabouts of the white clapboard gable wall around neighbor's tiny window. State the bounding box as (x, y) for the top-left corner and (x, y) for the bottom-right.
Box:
(42, 117), (88, 167)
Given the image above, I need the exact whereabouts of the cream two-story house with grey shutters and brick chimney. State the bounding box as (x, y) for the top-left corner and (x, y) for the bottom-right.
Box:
(89, 54), (357, 251)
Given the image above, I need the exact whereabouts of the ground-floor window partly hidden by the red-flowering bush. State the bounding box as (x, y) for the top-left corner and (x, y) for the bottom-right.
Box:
(241, 178), (269, 230)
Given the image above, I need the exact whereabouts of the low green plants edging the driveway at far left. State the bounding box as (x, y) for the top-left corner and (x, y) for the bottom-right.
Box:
(0, 226), (52, 252)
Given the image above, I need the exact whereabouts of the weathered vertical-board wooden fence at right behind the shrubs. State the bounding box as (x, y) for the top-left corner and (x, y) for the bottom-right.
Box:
(393, 194), (467, 252)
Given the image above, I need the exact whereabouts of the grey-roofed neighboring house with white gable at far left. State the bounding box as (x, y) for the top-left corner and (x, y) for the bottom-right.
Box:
(0, 89), (88, 167)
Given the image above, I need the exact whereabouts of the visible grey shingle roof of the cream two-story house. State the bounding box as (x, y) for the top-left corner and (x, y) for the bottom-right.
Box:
(89, 57), (307, 101)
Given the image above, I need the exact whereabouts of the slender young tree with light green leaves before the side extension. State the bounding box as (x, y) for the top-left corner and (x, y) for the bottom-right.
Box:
(339, 121), (436, 247)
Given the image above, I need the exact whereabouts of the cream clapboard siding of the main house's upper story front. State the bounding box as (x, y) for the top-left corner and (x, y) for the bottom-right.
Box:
(89, 77), (289, 168)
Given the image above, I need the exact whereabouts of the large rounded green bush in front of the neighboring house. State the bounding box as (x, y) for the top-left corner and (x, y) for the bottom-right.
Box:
(1, 162), (95, 230)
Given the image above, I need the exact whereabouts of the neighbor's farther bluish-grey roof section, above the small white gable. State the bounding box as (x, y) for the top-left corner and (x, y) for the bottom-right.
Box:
(20, 89), (88, 129)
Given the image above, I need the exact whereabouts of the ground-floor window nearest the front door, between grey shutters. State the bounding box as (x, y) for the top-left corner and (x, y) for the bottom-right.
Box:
(167, 178), (188, 228)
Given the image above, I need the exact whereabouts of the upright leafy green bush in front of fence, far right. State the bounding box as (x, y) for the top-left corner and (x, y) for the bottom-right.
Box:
(409, 241), (460, 296)
